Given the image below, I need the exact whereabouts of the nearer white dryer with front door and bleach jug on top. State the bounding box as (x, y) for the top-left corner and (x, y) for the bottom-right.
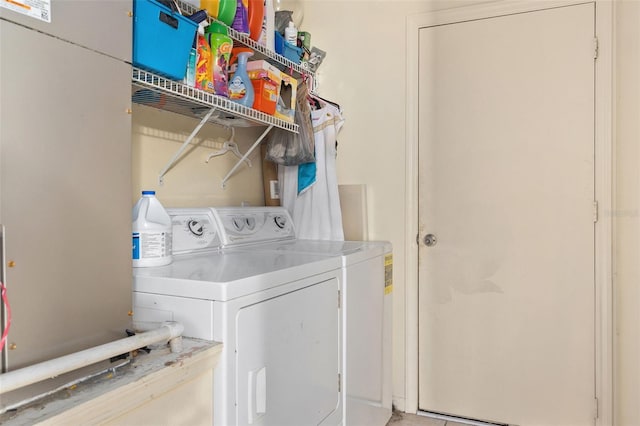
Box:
(133, 208), (344, 426)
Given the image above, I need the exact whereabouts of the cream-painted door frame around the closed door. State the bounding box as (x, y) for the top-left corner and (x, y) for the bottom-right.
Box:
(398, 0), (615, 426)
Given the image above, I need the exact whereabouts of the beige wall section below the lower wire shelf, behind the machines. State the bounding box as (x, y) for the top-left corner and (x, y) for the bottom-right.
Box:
(131, 104), (264, 207)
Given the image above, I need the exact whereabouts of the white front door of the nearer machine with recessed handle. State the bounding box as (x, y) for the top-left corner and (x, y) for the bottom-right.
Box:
(236, 278), (340, 426)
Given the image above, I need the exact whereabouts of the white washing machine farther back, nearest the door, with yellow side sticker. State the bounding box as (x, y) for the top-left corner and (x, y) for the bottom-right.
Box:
(213, 207), (393, 426)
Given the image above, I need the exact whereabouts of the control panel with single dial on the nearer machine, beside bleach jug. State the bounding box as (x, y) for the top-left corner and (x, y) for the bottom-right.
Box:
(167, 207), (222, 255)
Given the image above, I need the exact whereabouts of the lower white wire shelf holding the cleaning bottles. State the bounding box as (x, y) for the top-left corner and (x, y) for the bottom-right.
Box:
(131, 67), (298, 133)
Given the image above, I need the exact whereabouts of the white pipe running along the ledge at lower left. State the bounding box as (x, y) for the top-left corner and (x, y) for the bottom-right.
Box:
(0, 322), (184, 394)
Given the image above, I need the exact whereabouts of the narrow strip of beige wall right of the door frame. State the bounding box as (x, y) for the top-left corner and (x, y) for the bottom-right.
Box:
(614, 0), (640, 426)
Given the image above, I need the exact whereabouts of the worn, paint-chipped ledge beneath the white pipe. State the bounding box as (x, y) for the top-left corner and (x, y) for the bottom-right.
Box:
(0, 338), (222, 426)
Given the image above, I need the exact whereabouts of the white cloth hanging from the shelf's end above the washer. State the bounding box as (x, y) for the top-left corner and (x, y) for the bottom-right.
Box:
(278, 103), (344, 241)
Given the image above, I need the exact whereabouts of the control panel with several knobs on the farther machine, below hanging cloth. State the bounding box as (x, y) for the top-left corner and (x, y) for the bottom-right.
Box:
(211, 207), (296, 247)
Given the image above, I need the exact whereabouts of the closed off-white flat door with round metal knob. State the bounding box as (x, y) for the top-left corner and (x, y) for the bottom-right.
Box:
(419, 4), (595, 426)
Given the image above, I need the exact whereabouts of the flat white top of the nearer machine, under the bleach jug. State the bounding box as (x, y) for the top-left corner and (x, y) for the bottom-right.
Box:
(133, 250), (342, 301)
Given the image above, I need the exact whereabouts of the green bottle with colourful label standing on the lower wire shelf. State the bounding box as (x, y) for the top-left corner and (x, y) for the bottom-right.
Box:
(205, 22), (233, 98)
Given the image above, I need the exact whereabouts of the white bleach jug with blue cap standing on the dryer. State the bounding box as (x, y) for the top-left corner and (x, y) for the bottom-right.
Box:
(132, 191), (173, 268)
